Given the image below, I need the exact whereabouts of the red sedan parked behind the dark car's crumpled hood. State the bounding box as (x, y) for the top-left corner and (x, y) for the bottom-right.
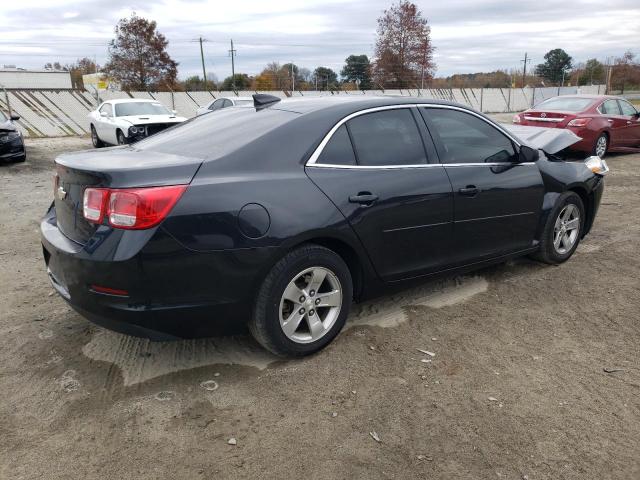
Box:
(513, 95), (640, 158)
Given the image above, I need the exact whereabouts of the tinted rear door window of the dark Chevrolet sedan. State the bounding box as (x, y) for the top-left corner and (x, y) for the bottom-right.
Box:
(347, 108), (427, 166)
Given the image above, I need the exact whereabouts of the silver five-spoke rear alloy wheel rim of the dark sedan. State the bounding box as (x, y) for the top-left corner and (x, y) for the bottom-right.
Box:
(279, 267), (342, 343)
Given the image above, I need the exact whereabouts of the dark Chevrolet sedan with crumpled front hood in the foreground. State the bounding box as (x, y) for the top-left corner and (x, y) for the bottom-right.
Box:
(41, 97), (606, 356)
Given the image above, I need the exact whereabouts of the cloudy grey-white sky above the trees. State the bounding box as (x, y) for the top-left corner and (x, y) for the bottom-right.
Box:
(0, 0), (640, 79)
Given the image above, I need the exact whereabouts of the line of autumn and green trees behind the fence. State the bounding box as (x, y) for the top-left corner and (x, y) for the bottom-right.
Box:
(45, 0), (640, 91)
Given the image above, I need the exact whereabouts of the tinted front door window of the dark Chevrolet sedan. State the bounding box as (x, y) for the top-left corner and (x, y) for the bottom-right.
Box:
(426, 108), (517, 163)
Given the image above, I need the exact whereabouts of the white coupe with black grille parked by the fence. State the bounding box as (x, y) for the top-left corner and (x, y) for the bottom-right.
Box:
(89, 99), (186, 148)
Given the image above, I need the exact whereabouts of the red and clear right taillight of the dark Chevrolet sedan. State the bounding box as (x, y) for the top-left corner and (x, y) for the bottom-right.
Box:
(83, 185), (187, 230)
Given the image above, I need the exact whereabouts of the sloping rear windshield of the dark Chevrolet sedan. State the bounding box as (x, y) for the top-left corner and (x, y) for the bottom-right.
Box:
(134, 108), (299, 159)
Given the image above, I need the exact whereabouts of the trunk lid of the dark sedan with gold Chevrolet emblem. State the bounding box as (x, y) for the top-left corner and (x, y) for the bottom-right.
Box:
(54, 147), (202, 245)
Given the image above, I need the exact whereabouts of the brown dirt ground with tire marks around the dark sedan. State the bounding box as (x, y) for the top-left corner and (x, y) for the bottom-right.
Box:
(0, 132), (640, 480)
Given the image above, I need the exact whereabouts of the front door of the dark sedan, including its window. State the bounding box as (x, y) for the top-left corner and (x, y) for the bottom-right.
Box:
(420, 106), (544, 265)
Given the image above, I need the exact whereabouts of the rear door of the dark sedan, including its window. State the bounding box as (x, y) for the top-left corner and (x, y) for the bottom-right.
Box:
(306, 106), (453, 281)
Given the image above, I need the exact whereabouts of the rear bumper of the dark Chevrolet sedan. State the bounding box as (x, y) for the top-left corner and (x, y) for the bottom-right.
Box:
(41, 204), (273, 340)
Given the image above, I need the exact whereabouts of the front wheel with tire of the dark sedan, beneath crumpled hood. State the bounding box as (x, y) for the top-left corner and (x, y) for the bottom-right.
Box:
(534, 192), (585, 265)
